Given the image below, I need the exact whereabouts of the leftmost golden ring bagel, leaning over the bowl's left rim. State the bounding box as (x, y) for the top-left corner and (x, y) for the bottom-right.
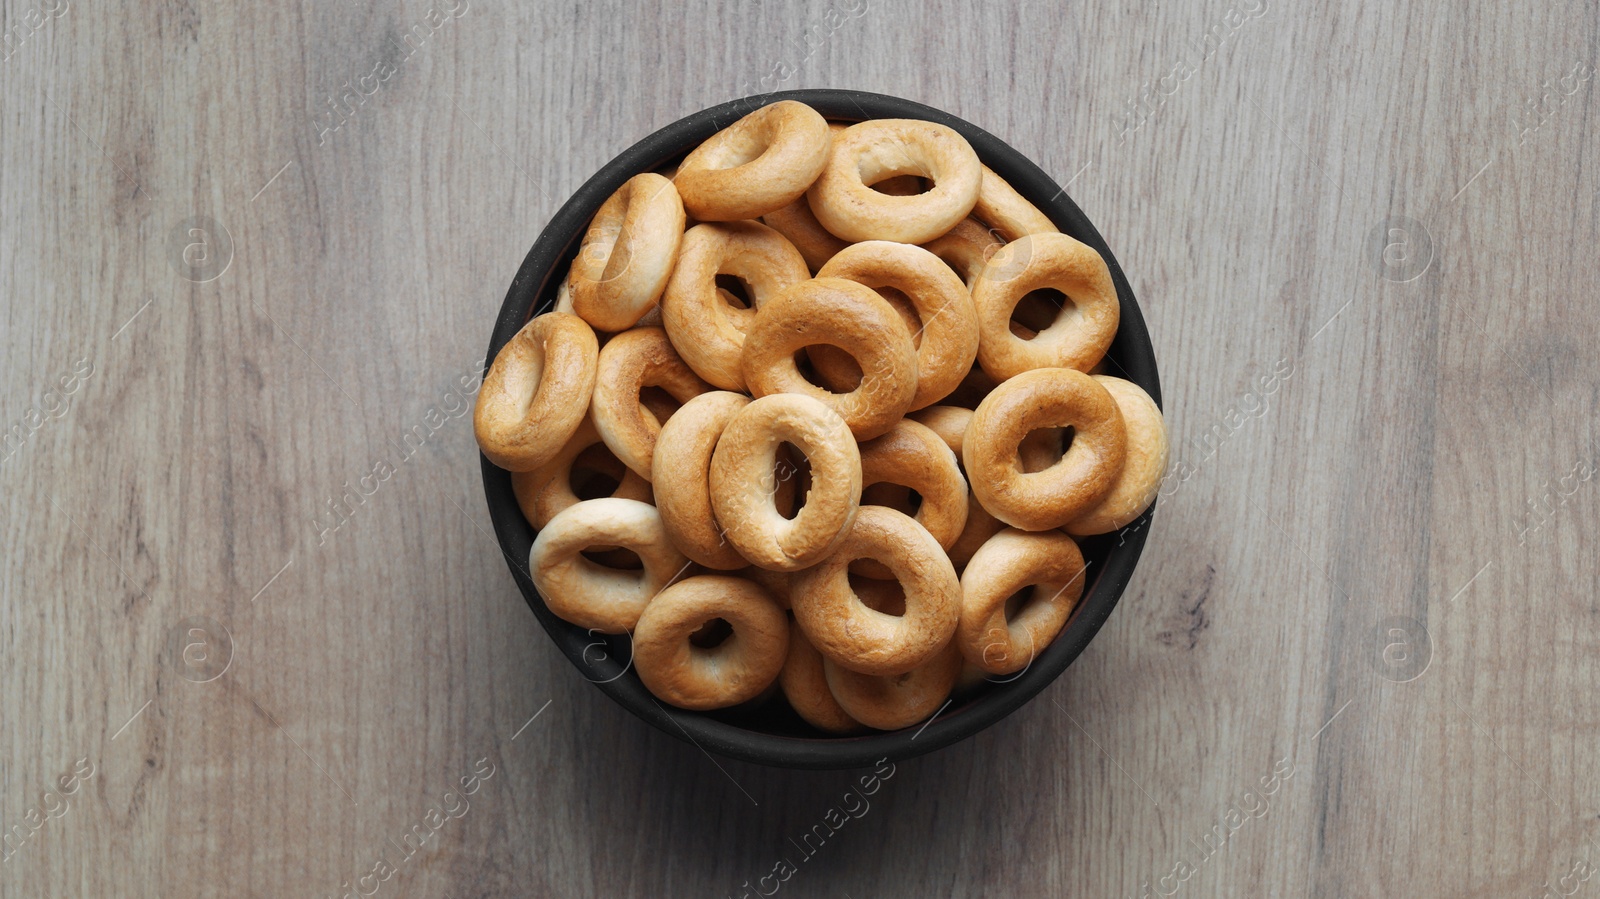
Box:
(472, 312), (600, 472)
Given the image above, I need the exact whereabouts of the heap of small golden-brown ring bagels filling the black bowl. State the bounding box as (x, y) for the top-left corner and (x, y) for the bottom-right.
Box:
(474, 101), (1166, 734)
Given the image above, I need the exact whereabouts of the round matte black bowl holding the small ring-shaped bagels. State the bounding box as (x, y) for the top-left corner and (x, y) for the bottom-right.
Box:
(482, 90), (1162, 768)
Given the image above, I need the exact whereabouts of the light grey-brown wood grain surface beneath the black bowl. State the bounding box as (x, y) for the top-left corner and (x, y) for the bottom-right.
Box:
(0, 0), (1600, 899)
